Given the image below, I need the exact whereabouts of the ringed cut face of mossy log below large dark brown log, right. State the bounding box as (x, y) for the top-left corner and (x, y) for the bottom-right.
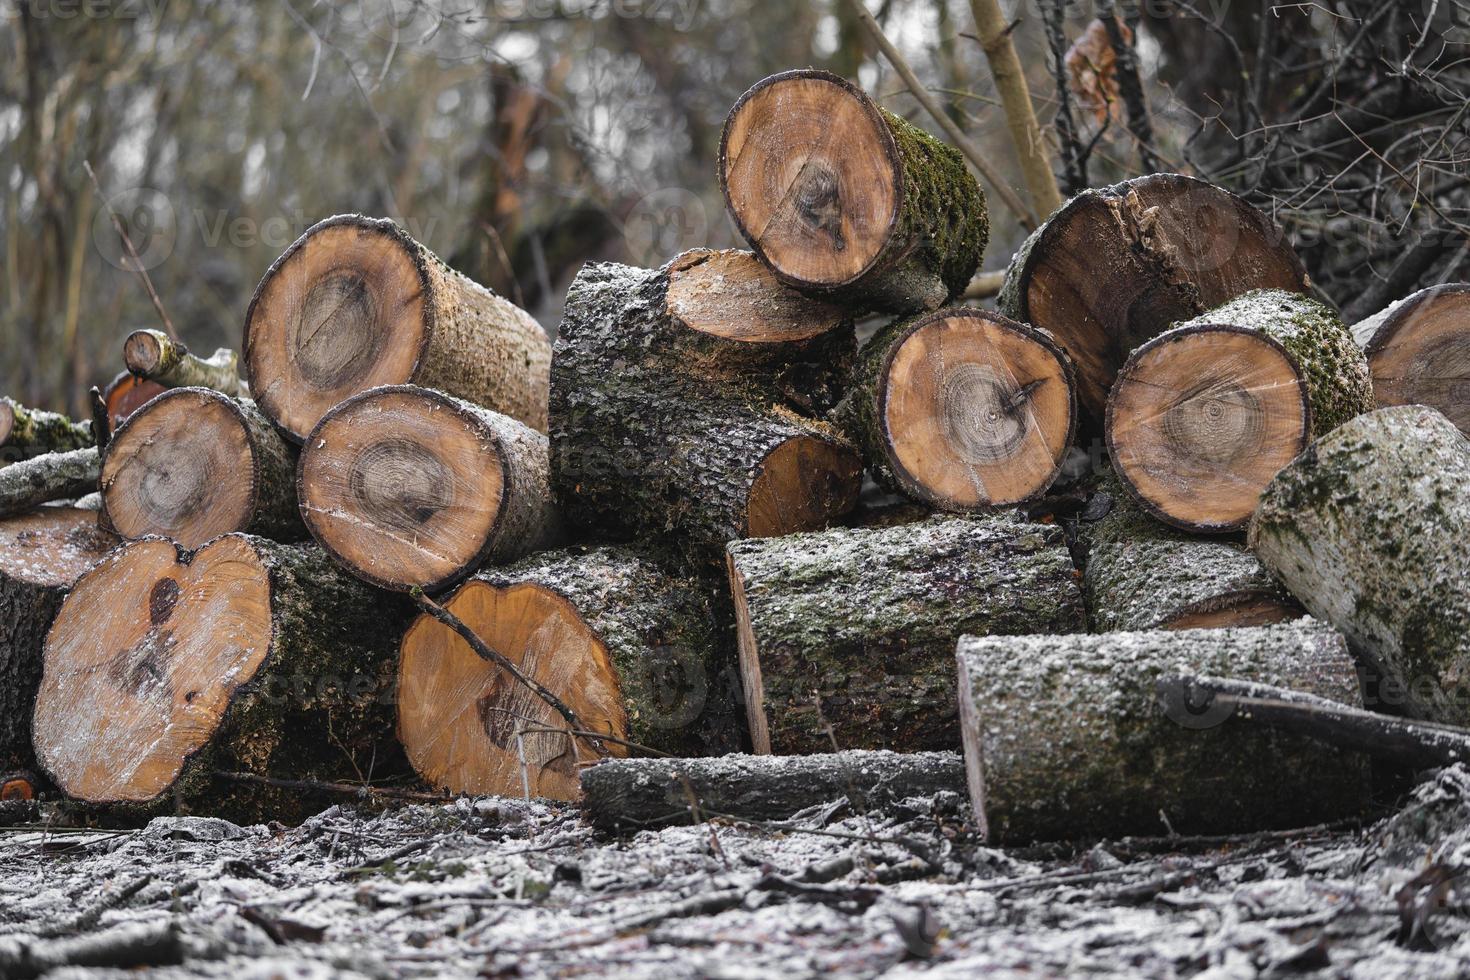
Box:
(1107, 323), (1311, 532)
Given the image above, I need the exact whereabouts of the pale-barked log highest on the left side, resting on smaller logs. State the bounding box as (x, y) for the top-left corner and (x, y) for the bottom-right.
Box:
(244, 215), (551, 442)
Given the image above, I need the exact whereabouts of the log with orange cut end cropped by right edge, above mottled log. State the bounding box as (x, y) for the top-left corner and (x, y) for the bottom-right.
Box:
(1352, 282), (1470, 435)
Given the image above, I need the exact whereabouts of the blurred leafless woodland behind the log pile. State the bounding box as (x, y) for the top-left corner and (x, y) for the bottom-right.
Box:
(0, 0), (1470, 413)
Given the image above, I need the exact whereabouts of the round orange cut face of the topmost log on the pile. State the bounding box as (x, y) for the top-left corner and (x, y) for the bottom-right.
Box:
(720, 69), (904, 288)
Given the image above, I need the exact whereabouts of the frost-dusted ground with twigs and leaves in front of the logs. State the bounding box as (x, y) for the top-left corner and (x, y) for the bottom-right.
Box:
(0, 767), (1470, 980)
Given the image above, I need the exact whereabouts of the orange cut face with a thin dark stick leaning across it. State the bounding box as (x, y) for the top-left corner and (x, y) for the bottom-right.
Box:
(397, 579), (628, 799)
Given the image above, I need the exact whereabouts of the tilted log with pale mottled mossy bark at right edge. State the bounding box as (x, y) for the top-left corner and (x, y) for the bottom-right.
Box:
(1251, 406), (1470, 724)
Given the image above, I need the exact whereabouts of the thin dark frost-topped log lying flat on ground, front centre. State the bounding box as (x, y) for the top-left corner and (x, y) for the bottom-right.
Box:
(582, 751), (964, 830)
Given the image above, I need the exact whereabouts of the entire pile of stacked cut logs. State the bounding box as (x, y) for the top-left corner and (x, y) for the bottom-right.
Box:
(0, 71), (1470, 842)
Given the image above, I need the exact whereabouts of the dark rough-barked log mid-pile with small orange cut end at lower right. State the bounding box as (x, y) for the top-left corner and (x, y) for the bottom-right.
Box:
(550, 264), (861, 551)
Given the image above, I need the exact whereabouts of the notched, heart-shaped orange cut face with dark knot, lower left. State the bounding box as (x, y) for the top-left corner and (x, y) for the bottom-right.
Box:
(34, 535), (273, 802)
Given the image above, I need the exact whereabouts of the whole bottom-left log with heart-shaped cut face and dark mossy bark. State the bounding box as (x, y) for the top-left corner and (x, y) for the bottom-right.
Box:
(34, 533), (410, 820)
